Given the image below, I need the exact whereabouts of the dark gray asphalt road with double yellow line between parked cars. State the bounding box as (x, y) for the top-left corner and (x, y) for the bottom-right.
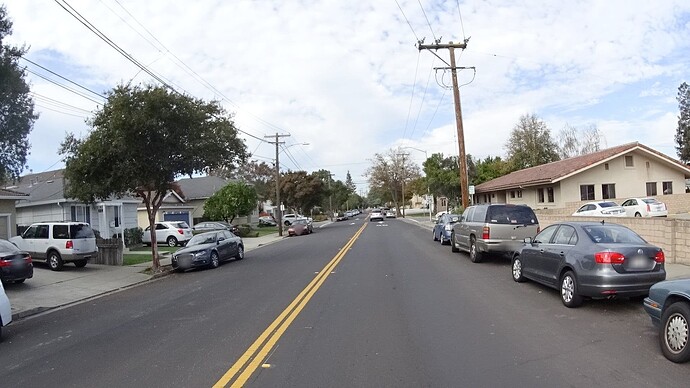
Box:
(0, 216), (690, 387)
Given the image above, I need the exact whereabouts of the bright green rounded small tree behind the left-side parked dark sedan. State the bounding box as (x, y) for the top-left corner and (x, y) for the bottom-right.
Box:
(204, 182), (257, 222)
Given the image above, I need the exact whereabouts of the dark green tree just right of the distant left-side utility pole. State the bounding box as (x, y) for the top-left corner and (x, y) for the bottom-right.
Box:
(280, 171), (325, 213)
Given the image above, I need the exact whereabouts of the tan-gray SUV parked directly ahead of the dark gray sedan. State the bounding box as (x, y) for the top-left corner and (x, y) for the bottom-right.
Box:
(450, 204), (539, 263)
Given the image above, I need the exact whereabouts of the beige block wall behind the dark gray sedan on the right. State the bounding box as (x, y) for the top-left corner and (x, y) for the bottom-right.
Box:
(537, 215), (690, 265)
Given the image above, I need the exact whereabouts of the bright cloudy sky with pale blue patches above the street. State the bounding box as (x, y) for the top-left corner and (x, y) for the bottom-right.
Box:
(0, 0), (690, 194)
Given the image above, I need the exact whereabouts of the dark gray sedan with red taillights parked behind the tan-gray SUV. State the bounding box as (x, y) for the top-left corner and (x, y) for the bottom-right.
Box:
(511, 222), (666, 307)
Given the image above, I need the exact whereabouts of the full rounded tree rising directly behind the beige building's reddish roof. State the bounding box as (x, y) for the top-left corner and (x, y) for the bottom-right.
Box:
(505, 114), (560, 170)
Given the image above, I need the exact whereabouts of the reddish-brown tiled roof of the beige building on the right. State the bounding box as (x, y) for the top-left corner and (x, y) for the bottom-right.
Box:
(475, 142), (690, 193)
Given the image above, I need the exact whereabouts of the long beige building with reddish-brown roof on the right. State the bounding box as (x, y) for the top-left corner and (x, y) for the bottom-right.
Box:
(472, 142), (690, 209)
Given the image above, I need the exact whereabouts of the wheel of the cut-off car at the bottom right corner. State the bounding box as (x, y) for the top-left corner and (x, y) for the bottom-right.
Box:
(659, 302), (690, 363)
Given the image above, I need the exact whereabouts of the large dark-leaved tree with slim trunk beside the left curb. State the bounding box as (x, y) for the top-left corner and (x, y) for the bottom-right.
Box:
(60, 85), (246, 271)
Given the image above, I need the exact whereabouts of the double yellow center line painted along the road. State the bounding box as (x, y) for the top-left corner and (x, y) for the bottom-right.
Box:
(213, 222), (367, 387)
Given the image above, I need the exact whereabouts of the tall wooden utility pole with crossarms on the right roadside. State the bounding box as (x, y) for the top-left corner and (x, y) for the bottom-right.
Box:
(417, 39), (470, 209)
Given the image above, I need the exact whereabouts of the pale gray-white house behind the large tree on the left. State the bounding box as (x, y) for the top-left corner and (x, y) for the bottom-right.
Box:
(8, 170), (141, 238)
